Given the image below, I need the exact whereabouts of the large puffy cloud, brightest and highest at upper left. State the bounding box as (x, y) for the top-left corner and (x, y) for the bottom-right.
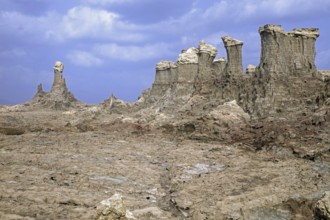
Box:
(46, 6), (145, 42)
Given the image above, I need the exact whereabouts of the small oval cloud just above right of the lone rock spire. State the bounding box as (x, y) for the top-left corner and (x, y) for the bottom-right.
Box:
(67, 50), (103, 67)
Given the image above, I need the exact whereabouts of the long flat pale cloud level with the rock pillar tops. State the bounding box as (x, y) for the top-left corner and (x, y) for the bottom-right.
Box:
(94, 43), (171, 61)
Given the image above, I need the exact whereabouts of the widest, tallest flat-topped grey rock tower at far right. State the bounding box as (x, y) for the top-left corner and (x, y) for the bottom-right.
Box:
(259, 24), (319, 76)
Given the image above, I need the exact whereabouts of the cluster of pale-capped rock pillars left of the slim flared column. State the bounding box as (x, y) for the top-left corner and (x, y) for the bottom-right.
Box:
(148, 41), (225, 104)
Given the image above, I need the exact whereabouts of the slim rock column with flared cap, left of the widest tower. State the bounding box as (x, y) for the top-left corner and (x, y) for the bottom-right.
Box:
(222, 36), (243, 75)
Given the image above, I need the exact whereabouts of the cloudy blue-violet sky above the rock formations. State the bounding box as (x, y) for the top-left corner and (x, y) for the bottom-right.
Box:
(0, 0), (330, 104)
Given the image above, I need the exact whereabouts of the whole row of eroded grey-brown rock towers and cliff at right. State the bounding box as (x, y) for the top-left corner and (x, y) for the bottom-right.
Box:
(147, 25), (330, 118)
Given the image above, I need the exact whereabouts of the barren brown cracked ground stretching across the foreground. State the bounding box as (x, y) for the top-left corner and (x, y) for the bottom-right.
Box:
(0, 111), (330, 219)
